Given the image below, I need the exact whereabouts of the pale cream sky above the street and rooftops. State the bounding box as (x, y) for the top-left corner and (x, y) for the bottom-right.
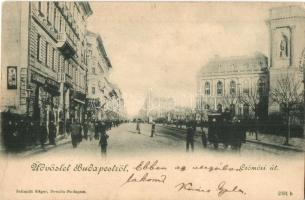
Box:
(87, 2), (294, 116)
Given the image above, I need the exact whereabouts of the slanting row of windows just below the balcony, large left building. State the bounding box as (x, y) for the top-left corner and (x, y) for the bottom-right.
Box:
(36, 34), (85, 88)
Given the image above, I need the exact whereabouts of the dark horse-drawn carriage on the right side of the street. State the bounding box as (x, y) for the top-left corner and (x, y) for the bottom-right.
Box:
(206, 113), (246, 149)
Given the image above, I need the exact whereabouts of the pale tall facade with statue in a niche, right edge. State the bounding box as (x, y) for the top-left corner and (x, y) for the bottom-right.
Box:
(267, 6), (305, 113)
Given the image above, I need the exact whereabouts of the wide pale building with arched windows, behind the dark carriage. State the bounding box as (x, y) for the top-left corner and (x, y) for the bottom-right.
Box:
(196, 53), (269, 117)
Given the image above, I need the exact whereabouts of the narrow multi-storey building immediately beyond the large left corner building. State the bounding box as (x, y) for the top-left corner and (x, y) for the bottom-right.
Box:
(86, 31), (112, 119)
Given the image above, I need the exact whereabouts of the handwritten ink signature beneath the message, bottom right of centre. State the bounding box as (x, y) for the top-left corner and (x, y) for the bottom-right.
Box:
(175, 181), (246, 197)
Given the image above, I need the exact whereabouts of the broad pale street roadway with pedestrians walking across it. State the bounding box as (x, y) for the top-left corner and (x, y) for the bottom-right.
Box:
(26, 123), (300, 158)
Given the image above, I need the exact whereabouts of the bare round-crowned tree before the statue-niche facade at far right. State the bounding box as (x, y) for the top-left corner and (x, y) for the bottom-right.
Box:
(270, 73), (304, 145)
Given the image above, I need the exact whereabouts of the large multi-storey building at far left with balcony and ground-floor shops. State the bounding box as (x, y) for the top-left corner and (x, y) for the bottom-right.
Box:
(1, 1), (92, 129)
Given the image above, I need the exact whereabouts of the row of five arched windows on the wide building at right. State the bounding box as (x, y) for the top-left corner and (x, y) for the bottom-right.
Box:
(204, 80), (265, 96)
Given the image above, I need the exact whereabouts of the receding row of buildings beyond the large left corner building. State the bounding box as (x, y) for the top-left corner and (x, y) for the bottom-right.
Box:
(86, 31), (125, 120)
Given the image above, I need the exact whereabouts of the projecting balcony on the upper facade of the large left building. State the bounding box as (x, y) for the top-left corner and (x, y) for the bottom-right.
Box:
(57, 33), (76, 58)
